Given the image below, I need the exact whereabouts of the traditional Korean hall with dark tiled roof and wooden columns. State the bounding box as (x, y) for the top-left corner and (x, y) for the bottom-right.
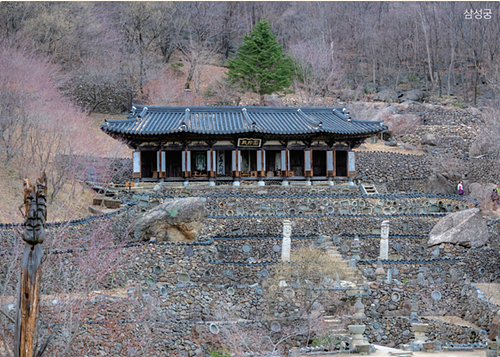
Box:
(101, 105), (387, 185)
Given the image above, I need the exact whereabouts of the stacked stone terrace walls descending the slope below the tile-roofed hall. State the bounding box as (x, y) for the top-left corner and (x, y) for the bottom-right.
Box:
(0, 181), (498, 356)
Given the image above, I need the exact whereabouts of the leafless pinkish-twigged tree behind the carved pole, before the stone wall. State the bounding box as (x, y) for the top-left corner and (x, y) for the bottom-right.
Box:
(0, 217), (139, 356)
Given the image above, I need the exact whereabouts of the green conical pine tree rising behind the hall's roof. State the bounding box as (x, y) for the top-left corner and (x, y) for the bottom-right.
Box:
(227, 20), (292, 105)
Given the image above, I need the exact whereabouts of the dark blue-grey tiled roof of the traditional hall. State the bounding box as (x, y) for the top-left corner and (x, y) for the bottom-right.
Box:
(101, 105), (387, 136)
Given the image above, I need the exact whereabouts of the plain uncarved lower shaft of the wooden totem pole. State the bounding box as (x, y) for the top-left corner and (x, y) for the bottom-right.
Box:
(14, 243), (43, 357)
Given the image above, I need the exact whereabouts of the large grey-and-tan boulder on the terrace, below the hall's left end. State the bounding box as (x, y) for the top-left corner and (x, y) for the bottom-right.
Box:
(134, 197), (208, 242)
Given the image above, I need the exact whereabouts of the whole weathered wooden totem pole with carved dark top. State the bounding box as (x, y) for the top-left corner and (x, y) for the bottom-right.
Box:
(14, 172), (47, 357)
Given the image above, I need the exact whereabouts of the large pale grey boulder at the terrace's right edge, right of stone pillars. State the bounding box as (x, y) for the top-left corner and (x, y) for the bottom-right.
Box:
(427, 208), (490, 248)
